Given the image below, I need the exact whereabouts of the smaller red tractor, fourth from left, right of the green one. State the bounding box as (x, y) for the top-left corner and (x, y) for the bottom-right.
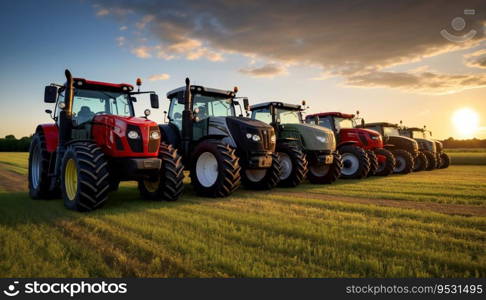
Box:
(305, 112), (395, 179)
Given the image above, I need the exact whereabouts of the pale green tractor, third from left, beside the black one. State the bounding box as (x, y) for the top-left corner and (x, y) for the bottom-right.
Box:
(245, 102), (343, 187)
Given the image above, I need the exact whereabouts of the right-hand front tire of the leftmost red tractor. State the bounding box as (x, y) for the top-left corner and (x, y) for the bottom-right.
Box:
(138, 143), (184, 201)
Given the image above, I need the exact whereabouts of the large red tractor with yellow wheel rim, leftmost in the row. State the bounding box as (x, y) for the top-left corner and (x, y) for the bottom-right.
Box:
(29, 70), (183, 211)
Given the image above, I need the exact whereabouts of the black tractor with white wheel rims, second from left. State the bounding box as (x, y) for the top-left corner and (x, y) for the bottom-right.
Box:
(159, 78), (280, 197)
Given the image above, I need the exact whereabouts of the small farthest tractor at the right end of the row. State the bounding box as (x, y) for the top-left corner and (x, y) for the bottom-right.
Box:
(400, 122), (450, 171)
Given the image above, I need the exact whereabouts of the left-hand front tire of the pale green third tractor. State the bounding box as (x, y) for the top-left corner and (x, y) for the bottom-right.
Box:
(277, 143), (308, 187)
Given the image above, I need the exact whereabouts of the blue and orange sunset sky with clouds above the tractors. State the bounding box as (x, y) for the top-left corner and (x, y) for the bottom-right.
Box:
(0, 0), (486, 139)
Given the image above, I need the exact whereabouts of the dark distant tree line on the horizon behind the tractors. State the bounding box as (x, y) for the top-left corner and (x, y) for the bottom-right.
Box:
(0, 134), (486, 152)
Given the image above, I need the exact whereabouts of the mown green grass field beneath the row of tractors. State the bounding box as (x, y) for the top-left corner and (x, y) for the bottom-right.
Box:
(0, 153), (486, 277)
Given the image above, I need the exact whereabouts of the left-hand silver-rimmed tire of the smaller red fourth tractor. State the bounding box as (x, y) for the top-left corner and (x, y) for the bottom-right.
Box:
(339, 145), (370, 179)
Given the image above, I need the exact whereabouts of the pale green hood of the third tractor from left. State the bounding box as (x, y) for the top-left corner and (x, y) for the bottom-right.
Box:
(279, 124), (336, 152)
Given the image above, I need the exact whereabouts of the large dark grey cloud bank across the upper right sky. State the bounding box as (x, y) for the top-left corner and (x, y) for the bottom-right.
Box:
(98, 0), (486, 90)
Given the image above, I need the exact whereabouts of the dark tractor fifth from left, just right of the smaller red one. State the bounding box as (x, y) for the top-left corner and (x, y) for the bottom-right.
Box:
(357, 122), (419, 174)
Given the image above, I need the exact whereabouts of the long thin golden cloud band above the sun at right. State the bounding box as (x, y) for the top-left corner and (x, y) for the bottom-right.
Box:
(346, 71), (486, 95)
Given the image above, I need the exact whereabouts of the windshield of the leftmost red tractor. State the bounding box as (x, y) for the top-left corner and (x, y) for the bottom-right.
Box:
(72, 89), (134, 125)
